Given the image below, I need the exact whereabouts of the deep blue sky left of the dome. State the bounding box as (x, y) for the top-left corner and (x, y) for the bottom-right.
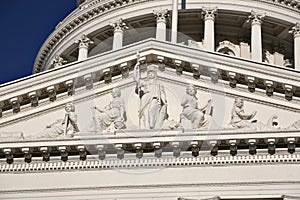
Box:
(0, 0), (76, 84)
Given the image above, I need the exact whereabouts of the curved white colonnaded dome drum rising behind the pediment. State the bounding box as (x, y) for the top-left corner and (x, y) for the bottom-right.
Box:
(34, 0), (300, 73)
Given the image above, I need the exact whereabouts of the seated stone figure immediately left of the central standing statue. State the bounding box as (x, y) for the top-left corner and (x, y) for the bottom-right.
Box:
(94, 88), (127, 130)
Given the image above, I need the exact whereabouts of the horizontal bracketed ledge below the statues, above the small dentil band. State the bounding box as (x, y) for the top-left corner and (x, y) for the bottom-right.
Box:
(0, 129), (300, 165)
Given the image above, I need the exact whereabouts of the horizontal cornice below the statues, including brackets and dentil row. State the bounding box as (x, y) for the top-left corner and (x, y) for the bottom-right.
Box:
(0, 129), (300, 168)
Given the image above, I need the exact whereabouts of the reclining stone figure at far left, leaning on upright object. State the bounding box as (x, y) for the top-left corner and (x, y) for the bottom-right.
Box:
(36, 103), (79, 138)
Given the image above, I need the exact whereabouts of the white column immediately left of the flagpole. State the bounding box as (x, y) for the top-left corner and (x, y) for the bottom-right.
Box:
(153, 9), (168, 41)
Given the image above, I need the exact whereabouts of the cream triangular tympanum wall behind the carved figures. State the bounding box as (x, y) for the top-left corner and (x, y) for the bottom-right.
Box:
(0, 63), (300, 140)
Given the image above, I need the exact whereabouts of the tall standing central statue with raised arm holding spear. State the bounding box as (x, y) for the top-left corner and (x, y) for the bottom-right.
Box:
(134, 64), (168, 129)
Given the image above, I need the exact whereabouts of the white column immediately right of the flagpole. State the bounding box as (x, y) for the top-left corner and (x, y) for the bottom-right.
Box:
(202, 8), (217, 51)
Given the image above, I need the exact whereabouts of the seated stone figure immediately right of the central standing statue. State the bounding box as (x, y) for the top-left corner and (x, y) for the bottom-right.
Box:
(180, 85), (212, 129)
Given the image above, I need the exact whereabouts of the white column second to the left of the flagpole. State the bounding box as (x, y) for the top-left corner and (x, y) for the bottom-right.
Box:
(110, 19), (128, 50)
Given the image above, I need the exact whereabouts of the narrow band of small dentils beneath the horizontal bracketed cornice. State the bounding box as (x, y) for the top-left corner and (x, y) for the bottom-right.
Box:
(0, 150), (300, 174)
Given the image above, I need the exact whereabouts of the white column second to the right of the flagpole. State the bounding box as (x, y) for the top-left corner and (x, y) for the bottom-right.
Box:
(248, 10), (265, 62)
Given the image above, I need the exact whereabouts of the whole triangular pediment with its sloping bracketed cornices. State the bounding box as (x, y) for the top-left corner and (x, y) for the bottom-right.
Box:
(0, 40), (300, 141)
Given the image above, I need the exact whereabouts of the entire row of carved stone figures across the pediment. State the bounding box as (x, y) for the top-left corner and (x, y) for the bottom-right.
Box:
(4, 81), (300, 141)
